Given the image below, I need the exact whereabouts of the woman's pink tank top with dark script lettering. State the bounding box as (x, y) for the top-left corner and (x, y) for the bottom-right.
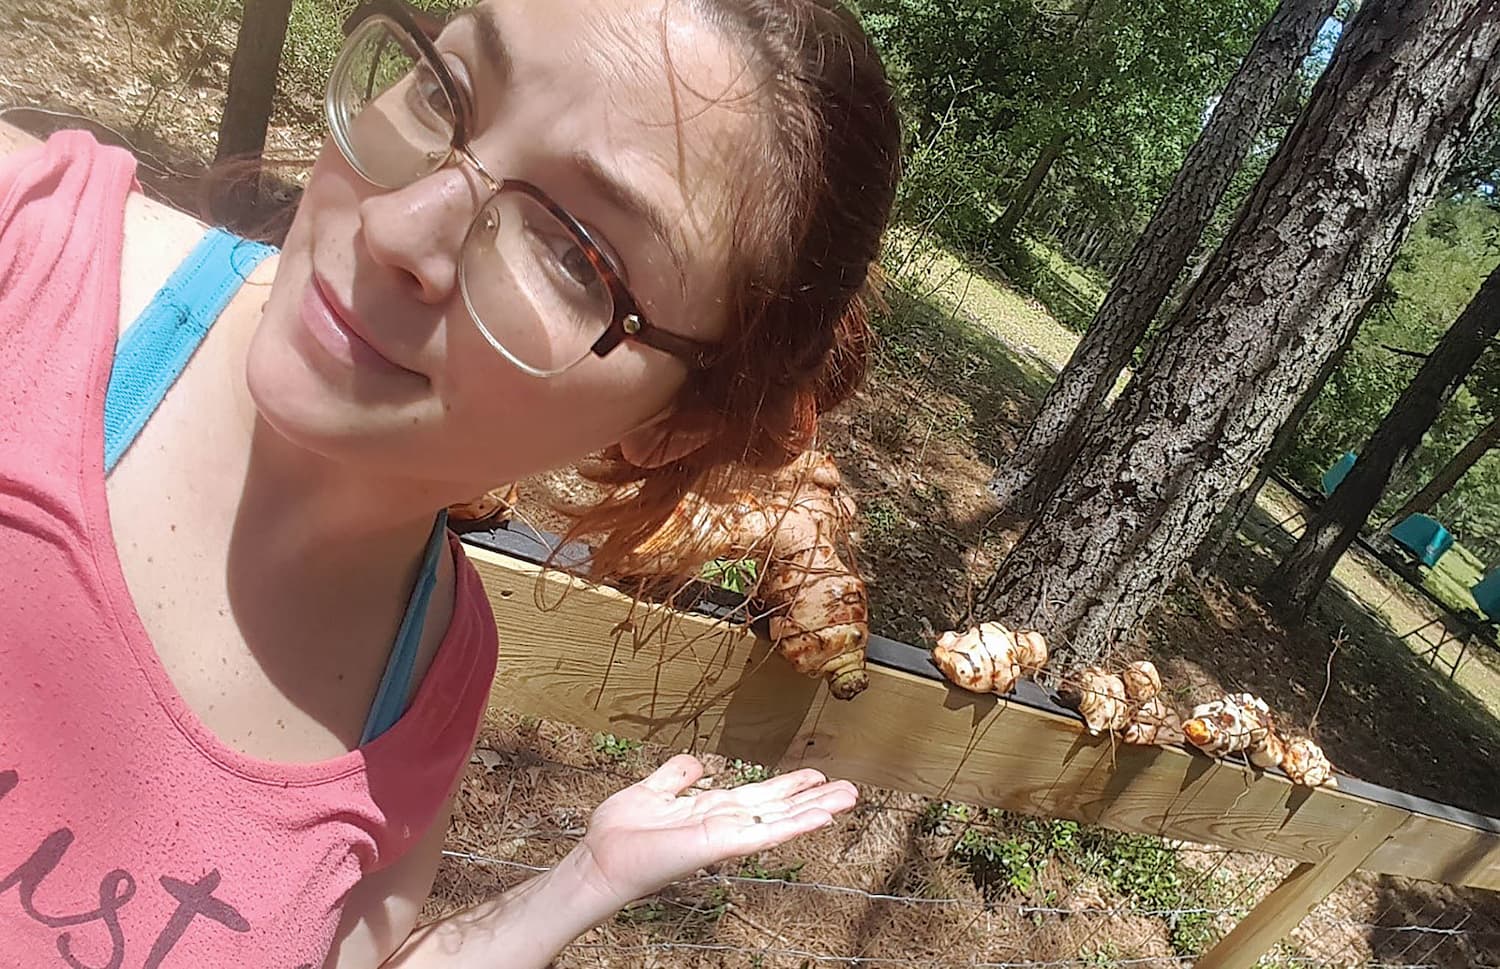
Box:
(0, 132), (497, 969)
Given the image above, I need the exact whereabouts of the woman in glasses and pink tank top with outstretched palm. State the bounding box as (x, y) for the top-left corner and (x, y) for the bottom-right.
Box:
(0, 0), (899, 969)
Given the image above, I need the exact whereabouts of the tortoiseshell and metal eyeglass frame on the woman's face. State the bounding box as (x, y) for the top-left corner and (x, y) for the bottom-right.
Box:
(330, 0), (719, 377)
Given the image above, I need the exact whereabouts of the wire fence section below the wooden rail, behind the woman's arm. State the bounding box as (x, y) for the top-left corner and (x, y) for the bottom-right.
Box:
(429, 714), (1500, 969)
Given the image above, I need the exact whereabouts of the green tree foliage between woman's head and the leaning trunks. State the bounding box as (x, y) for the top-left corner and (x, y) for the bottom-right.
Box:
(860, 0), (1274, 259)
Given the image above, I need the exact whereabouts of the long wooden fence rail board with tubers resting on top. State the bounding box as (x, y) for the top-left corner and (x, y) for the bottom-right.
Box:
(470, 548), (1500, 890)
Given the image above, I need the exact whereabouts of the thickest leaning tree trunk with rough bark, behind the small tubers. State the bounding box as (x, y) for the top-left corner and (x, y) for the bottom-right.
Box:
(990, 0), (1500, 660)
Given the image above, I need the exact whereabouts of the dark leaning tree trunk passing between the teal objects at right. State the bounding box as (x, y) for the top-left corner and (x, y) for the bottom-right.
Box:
(1266, 262), (1500, 617)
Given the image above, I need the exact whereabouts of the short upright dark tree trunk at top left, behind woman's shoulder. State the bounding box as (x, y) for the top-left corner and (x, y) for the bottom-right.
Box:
(215, 0), (291, 162)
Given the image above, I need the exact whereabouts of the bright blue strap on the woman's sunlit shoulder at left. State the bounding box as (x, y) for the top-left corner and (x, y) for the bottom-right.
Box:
(104, 228), (276, 474)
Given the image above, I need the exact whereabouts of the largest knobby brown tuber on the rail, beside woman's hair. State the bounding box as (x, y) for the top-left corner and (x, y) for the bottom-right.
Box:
(632, 452), (870, 699)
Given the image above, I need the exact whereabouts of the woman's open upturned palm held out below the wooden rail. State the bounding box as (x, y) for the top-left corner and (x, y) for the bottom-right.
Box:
(581, 755), (860, 908)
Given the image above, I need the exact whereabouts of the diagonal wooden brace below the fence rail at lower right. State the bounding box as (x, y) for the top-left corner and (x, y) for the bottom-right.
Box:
(1196, 809), (1407, 969)
